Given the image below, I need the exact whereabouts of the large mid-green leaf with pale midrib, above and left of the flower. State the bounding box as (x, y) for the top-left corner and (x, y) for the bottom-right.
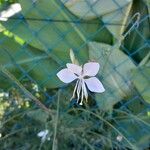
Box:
(3, 0), (112, 63)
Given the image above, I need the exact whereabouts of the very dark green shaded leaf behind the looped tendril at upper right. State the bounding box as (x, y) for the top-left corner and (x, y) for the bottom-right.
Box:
(122, 0), (150, 63)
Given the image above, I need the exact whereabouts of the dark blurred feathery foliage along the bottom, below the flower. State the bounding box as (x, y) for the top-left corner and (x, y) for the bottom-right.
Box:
(0, 87), (150, 150)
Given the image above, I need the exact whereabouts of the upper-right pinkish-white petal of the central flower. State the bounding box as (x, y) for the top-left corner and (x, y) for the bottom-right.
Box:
(83, 62), (100, 76)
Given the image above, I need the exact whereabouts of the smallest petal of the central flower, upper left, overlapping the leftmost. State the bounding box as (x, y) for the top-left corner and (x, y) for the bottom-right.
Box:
(66, 63), (82, 75)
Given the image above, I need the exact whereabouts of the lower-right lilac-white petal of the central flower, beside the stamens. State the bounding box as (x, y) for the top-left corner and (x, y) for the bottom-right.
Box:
(84, 77), (105, 93)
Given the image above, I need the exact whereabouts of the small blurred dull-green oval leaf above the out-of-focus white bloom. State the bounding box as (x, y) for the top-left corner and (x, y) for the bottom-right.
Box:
(27, 109), (49, 123)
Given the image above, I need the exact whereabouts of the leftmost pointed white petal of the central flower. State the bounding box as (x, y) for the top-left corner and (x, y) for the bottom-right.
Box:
(57, 68), (77, 83)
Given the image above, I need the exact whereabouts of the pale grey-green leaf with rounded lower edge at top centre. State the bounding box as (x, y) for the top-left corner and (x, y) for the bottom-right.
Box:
(61, 0), (132, 19)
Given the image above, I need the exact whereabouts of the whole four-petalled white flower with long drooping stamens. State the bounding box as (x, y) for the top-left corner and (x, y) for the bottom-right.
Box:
(57, 62), (105, 105)
